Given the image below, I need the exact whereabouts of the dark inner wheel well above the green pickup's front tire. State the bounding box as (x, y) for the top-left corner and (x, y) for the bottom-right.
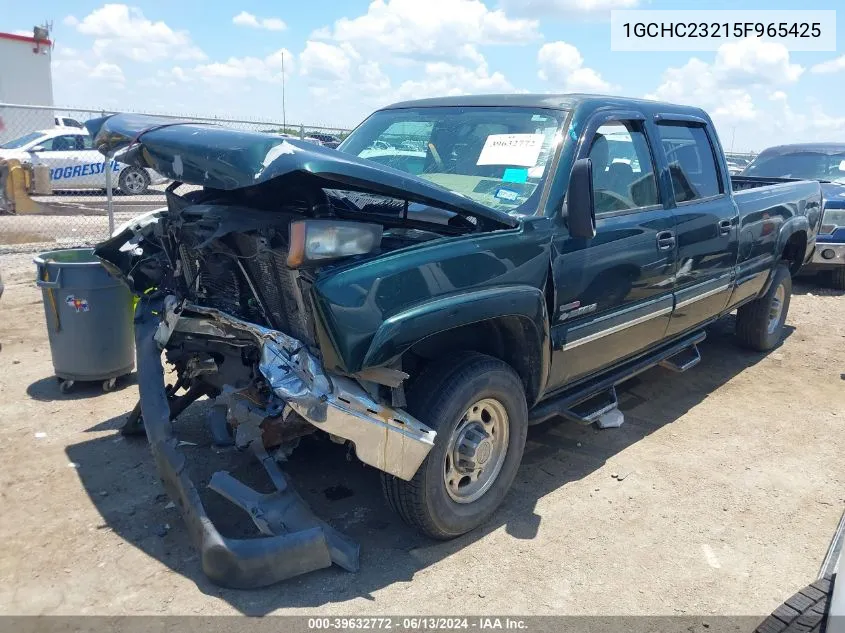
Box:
(402, 316), (542, 406)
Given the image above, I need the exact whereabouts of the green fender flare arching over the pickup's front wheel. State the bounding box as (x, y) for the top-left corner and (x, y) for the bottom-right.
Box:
(361, 285), (551, 400)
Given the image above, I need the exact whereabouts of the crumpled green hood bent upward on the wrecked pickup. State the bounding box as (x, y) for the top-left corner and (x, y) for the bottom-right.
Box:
(85, 114), (519, 227)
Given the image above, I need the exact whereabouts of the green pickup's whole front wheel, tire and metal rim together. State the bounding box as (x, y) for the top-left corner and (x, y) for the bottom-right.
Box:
(382, 352), (528, 540)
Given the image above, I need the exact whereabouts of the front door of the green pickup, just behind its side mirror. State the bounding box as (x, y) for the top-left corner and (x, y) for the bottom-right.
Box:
(549, 112), (675, 389)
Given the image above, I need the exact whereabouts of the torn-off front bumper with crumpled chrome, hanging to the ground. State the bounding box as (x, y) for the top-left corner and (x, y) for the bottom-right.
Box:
(135, 297), (434, 589)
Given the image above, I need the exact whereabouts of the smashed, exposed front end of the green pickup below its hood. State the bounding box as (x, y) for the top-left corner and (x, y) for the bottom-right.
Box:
(109, 199), (435, 588)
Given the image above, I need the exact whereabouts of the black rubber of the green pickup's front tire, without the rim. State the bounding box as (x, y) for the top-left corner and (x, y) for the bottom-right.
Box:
(382, 352), (528, 539)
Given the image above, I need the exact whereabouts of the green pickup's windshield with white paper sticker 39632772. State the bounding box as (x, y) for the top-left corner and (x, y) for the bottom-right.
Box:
(338, 107), (566, 213)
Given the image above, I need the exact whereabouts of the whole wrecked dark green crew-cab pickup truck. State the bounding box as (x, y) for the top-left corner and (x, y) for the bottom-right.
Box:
(94, 95), (821, 587)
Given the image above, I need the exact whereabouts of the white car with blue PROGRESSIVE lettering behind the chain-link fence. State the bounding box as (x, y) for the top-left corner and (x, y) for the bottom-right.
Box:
(0, 127), (166, 195)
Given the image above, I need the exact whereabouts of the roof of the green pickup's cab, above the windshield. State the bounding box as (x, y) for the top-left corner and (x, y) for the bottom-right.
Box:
(383, 93), (704, 116)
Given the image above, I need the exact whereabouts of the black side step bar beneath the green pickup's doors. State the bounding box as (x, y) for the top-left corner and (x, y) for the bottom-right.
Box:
(528, 330), (707, 426)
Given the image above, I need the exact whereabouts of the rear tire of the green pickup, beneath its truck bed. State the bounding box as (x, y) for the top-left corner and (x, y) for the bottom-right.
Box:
(736, 264), (792, 352)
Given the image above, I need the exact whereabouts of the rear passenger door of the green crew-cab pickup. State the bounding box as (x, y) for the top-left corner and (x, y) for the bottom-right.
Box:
(655, 115), (739, 336)
